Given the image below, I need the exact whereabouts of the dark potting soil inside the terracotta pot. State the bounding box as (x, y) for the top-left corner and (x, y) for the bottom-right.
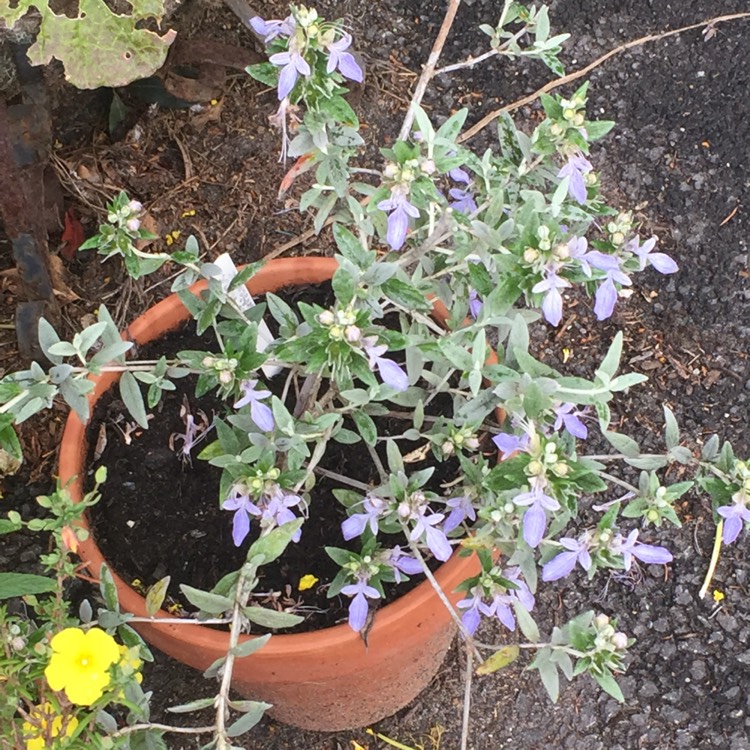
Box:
(87, 284), (457, 633)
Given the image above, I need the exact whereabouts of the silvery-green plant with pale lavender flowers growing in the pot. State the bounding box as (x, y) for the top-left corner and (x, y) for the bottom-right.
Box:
(0, 2), (750, 748)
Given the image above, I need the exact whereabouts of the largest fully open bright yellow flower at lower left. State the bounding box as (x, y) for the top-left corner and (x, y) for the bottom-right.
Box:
(44, 628), (120, 706)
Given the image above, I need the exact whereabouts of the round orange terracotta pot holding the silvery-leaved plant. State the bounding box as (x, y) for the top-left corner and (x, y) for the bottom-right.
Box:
(60, 257), (479, 731)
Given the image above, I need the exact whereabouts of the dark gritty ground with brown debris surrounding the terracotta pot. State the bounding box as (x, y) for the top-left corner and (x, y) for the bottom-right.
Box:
(0, 0), (750, 750)
